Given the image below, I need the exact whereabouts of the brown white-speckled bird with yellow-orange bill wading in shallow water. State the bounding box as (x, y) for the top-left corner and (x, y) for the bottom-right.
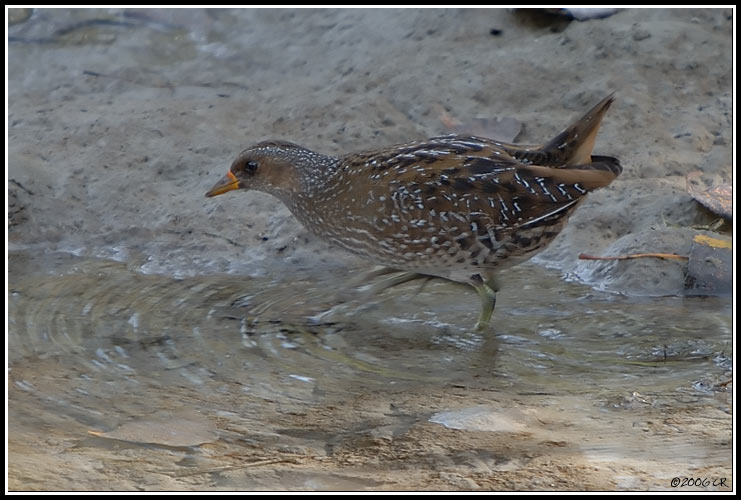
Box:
(206, 93), (622, 331)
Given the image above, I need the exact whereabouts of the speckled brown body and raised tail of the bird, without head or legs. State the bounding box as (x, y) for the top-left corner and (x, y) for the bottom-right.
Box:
(286, 96), (622, 279)
